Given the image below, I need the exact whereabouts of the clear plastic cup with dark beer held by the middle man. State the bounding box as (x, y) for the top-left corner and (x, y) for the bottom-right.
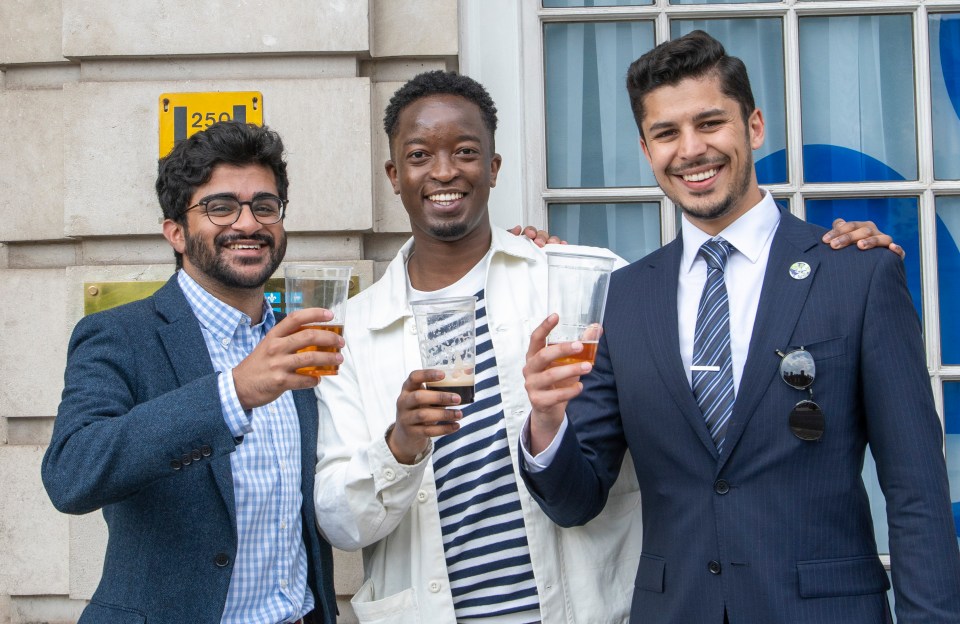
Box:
(410, 297), (477, 405)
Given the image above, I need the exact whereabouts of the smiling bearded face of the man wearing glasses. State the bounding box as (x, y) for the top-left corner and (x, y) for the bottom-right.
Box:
(163, 164), (287, 307)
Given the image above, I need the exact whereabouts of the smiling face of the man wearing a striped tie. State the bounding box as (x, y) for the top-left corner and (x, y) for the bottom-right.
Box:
(641, 76), (764, 235)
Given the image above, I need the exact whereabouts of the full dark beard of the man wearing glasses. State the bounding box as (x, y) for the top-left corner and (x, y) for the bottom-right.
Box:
(184, 227), (287, 288)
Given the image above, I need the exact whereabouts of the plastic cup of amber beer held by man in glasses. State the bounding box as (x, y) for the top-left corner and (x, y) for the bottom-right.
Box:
(283, 264), (353, 377)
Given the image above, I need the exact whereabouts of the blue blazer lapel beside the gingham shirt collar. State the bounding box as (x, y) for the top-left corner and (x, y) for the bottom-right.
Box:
(155, 274), (237, 526)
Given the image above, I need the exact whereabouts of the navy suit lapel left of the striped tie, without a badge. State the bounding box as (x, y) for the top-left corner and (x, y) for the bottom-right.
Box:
(639, 237), (717, 458)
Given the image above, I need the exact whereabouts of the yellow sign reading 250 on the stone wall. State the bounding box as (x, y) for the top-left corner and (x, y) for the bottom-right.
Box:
(160, 91), (263, 158)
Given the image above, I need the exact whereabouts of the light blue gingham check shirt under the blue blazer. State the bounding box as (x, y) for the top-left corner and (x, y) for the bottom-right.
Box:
(177, 271), (314, 624)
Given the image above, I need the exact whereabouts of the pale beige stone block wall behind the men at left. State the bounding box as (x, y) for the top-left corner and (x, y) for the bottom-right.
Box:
(0, 0), (458, 624)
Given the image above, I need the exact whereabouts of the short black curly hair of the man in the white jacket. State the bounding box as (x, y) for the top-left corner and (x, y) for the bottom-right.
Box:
(383, 70), (497, 149)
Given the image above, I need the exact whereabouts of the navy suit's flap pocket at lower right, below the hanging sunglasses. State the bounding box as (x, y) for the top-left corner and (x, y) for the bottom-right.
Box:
(797, 555), (890, 598)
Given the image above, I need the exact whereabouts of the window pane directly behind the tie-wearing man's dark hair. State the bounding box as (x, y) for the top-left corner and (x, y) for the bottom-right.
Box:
(670, 18), (787, 184)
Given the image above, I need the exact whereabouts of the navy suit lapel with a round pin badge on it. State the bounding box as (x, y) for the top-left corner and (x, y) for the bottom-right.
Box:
(719, 210), (820, 467)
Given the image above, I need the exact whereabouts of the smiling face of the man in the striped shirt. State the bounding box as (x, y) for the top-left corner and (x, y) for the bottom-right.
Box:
(385, 95), (500, 242)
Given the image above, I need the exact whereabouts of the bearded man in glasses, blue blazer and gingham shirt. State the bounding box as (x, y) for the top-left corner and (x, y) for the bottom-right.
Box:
(42, 122), (343, 624)
